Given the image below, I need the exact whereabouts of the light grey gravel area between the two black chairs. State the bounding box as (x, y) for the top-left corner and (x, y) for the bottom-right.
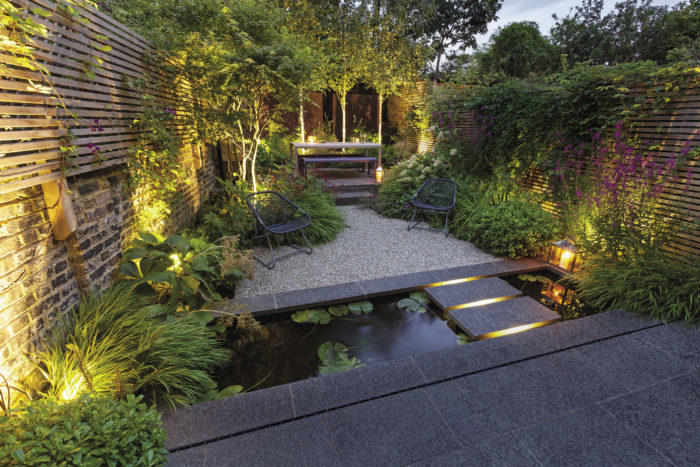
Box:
(236, 206), (497, 297)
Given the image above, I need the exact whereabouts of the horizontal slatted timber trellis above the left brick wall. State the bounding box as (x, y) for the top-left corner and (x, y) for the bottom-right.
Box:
(0, 0), (196, 238)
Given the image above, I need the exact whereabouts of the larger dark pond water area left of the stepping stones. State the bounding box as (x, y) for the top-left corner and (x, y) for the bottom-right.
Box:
(219, 295), (459, 389)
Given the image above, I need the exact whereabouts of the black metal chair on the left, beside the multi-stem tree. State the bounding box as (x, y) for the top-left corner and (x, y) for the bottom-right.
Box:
(245, 191), (313, 269)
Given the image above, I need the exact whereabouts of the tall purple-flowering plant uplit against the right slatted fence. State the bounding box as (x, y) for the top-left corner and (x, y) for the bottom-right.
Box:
(548, 122), (697, 258)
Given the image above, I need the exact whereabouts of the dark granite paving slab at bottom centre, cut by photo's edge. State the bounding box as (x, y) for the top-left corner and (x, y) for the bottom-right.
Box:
(329, 389), (460, 467)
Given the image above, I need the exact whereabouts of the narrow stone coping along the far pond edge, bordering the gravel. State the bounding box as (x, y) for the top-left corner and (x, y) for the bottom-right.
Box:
(231, 258), (547, 316)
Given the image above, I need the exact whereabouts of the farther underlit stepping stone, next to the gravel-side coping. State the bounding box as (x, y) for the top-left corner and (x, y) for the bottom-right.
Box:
(425, 277), (522, 311)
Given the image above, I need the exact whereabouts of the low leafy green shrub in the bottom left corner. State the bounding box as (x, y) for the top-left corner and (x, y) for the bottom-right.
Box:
(0, 394), (168, 466)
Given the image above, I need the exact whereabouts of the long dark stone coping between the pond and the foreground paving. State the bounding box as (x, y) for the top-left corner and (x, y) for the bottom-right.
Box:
(163, 310), (661, 451)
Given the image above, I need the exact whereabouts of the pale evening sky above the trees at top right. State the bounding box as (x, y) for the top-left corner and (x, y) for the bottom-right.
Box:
(477, 0), (679, 45)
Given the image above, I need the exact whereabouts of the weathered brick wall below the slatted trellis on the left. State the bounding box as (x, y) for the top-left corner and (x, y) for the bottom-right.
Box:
(0, 146), (217, 381)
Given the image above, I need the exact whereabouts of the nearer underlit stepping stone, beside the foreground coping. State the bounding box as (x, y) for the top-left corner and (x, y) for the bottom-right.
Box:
(449, 297), (561, 339)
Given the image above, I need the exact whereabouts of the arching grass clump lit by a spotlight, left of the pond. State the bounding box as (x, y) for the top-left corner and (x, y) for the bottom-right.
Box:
(36, 283), (228, 406)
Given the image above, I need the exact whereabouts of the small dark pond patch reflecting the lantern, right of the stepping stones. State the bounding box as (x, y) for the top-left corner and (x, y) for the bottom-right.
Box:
(501, 269), (600, 321)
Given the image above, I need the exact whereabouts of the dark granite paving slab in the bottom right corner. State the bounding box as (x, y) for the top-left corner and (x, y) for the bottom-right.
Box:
(600, 371), (700, 465)
